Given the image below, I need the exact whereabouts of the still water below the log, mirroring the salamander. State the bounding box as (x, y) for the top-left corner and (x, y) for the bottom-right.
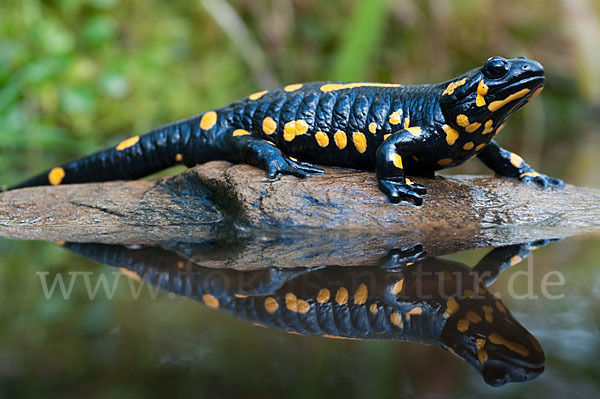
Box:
(0, 234), (600, 397)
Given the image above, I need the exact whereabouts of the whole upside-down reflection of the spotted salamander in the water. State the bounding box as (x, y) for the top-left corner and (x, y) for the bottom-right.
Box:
(67, 244), (544, 386)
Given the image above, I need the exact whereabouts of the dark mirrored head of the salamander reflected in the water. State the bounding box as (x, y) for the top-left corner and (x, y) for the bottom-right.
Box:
(441, 292), (545, 386)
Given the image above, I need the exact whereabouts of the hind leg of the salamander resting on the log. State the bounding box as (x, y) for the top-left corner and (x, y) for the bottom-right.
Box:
(223, 129), (324, 178)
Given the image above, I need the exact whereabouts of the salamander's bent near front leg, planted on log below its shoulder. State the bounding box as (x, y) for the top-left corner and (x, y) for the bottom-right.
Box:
(375, 130), (427, 205)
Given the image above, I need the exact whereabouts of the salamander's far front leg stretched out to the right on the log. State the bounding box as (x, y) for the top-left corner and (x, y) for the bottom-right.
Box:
(477, 140), (565, 188)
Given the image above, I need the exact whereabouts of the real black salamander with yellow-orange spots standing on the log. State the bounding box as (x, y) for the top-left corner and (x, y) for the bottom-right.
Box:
(7, 57), (564, 205)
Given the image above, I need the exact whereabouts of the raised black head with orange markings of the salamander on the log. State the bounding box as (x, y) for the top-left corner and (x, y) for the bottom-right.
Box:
(440, 57), (545, 136)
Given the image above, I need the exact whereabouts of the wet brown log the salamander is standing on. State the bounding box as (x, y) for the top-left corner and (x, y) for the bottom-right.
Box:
(0, 162), (600, 264)
